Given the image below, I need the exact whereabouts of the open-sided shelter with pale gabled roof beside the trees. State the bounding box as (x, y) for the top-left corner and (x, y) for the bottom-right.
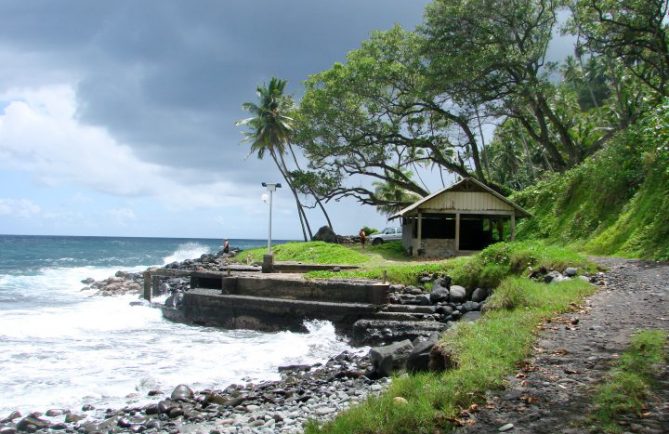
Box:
(390, 178), (530, 257)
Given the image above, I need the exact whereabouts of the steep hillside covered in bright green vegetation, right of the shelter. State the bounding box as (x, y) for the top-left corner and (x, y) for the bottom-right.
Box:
(514, 104), (669, 260)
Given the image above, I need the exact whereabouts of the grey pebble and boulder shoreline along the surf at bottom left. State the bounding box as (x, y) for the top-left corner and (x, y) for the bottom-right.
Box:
(0, 352), (390, 434)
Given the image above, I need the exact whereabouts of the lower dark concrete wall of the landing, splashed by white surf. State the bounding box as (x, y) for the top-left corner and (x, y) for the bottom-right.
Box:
(183, 288), (377, 335)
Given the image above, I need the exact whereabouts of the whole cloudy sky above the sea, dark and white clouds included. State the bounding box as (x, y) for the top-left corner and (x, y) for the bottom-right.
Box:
(0, 0), (572, 239)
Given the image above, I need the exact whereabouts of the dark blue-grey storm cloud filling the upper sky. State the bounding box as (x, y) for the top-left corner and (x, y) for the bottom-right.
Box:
(0, 0), (427, 182)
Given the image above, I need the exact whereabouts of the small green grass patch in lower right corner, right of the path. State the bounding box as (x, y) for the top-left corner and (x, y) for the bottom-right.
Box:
(592, 330), (668, 433)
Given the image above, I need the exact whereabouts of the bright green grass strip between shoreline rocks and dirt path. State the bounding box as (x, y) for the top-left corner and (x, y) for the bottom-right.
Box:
(306, 278), (594, 434)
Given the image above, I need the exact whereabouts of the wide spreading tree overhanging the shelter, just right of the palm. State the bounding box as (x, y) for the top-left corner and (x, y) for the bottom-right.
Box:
(296, 26), (486, 207)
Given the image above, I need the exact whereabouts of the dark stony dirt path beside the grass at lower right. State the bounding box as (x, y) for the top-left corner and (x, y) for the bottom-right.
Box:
(458, 258), (669, 434)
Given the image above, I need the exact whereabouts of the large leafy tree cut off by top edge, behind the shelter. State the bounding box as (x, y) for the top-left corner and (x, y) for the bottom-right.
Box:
(421, 0), (583, 170)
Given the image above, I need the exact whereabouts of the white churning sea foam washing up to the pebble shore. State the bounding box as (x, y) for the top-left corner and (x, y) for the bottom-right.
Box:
(0, 262), (358, 416)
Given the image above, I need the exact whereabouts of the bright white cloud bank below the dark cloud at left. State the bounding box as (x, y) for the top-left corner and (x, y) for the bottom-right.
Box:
(0, 85), (255, 210)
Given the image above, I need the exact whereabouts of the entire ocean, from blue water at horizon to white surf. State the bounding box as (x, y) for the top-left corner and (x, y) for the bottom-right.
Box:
(0, 235), (358, 418)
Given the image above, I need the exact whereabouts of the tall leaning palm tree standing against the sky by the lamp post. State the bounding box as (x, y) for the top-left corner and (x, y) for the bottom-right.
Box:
(236, 77), (311, 241)
